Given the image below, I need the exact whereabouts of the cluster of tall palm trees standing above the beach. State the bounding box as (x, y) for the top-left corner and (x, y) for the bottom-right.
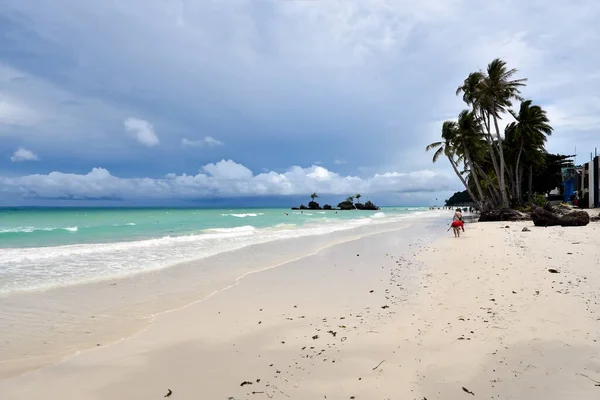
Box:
(426, 59), (552, 210)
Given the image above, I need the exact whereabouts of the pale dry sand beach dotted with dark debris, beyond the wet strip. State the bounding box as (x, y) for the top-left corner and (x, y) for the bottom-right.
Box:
(0, 217), (600, 400)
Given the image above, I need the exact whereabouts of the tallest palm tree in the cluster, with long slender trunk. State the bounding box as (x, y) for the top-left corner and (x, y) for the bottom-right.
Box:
(474, 58), (527, 207)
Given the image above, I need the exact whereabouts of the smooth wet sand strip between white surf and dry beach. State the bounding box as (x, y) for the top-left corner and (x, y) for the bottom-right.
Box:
(0, 213), (446, 379)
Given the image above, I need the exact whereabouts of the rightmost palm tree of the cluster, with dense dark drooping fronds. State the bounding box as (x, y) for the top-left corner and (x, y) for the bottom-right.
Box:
(506, 100), (553, 202)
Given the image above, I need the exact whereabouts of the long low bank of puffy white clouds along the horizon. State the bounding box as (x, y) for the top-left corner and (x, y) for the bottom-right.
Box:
(0, 160), (456, 200)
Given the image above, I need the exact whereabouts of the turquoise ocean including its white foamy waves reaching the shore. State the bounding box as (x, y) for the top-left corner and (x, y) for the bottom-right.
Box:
(0, 207), (427, 295)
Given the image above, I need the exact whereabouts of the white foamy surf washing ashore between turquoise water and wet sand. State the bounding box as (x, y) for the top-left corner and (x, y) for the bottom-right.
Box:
(0, 209), (431, 299)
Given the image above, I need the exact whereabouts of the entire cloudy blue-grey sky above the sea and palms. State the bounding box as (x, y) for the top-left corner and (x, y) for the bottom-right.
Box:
(0, 0), (600, 205)
